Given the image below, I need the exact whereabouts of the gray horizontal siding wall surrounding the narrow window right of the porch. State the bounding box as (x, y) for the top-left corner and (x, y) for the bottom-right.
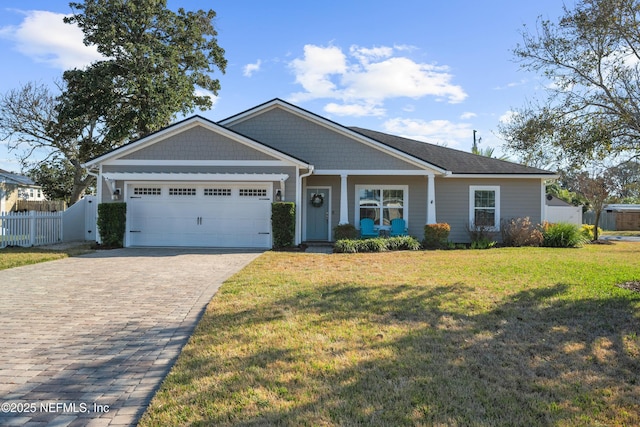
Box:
(435, 178), (542, 243)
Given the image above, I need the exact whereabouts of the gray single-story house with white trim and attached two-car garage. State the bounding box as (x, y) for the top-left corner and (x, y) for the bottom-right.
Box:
(84, 99), (556, 248)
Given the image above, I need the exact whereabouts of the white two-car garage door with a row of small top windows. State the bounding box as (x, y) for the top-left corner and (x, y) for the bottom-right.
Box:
(127, 182), (272, 248)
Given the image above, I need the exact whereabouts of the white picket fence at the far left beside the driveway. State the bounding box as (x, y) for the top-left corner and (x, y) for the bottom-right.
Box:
(0, 211), (63, 248)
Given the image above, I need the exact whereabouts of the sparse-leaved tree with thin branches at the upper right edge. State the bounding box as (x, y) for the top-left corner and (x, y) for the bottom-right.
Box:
(500, 0), (640, 166)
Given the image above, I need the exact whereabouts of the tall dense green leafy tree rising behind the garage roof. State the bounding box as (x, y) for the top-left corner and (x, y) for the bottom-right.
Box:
(64, 0), (226, 144)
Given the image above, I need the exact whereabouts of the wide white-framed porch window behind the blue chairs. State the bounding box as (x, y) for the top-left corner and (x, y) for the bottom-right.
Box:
(355, 185), (409, 227)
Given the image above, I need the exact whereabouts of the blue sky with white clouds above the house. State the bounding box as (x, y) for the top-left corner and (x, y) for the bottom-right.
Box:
(0, 0), (573, 171)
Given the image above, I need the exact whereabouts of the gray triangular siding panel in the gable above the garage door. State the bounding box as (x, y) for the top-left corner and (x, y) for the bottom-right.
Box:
(122, 126), (277, 160)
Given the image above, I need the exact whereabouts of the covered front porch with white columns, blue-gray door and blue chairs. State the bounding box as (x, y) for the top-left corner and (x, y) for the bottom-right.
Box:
(296, 170), (437, 243)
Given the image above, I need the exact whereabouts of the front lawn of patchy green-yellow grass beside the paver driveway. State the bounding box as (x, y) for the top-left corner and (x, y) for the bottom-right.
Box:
(141, 243), (640, 426)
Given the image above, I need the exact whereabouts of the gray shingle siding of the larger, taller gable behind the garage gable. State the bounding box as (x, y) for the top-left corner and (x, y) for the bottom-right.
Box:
(229, 108), (418, 170)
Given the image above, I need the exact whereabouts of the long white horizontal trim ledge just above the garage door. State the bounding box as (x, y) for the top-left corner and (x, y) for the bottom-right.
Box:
(102, 172), (289, 182)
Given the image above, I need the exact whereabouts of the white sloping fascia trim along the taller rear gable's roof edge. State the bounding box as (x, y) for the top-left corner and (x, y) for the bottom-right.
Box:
(220, 99), (447, 173)
